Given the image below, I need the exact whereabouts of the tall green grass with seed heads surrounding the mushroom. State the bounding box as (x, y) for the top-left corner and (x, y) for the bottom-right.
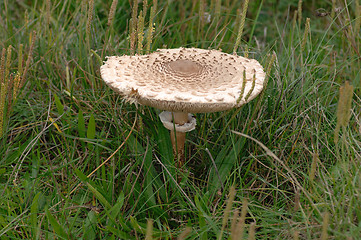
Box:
(0, 0), (361, 239)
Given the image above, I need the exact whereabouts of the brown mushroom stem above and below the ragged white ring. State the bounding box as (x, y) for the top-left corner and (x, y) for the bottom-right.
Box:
(170, 112), (188, 168)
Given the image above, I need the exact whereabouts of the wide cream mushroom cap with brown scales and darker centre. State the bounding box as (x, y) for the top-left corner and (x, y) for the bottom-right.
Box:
(100, 48), (266, 113)
